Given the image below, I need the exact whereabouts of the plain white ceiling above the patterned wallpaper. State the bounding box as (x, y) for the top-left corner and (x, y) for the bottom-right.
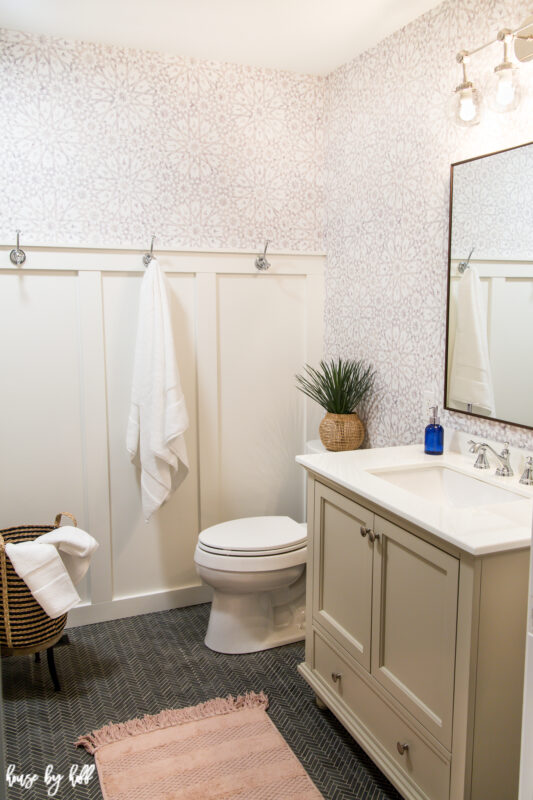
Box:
(0, 0), (441, 75)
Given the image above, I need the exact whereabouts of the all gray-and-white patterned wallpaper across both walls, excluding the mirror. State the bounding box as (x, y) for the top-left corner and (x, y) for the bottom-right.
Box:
(0, 6), (533, 446)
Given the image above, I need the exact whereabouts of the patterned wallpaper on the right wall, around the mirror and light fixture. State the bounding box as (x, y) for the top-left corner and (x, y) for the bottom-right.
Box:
(325, 0), (533, 447)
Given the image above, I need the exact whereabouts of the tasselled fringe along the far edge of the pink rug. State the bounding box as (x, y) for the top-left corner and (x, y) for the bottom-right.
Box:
(74, 692), (268, 755)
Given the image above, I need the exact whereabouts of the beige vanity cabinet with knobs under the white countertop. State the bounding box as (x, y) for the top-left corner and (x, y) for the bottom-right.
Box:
(300, 475), (528, 800)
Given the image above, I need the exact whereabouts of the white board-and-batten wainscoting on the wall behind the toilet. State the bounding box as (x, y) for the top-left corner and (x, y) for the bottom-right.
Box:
(0, 245), (324, 625)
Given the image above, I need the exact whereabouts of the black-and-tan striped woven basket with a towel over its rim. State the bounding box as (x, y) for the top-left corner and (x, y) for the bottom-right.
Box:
(0, 512), (77, 656)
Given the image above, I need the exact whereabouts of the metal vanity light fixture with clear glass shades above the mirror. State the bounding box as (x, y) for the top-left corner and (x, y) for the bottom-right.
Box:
(451, 17), (533, 127)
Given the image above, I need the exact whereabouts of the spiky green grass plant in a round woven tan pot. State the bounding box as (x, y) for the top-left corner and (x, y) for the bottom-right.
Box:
(296, 358), (375, 450)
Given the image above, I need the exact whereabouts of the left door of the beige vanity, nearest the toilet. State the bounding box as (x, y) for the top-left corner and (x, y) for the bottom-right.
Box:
(313, 483), (374, 670)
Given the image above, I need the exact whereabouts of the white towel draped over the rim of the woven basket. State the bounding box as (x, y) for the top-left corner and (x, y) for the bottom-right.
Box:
(6, 525), (98, 619)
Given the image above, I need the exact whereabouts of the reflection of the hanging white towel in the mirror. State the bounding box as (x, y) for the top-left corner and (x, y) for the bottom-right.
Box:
(449, 266), (495, 416)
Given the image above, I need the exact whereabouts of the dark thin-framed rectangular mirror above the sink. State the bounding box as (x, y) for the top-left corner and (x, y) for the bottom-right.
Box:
(444, 142), (533, 428)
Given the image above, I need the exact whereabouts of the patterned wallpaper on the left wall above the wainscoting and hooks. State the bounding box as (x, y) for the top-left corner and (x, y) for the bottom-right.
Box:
(0, 30), (324, 252)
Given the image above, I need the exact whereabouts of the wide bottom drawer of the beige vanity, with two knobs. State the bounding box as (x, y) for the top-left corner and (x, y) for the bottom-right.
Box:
(313, 632), (450, 800)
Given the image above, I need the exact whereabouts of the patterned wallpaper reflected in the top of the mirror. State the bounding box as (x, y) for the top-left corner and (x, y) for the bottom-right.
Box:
(452, 141), (533, 261)
